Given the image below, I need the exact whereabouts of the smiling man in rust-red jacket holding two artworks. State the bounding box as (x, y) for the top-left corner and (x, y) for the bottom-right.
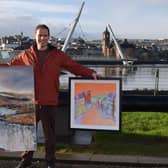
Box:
(2, 24), (97, 168)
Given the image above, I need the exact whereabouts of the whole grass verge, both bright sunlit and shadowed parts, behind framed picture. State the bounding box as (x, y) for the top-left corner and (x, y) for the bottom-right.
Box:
(55, 112), (168, 157)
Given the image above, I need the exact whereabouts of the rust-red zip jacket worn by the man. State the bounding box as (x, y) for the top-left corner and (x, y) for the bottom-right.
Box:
(3, 46), (94, 105)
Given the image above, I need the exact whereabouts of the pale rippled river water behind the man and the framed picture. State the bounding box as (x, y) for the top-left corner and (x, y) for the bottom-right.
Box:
(60, 64), (168, 91)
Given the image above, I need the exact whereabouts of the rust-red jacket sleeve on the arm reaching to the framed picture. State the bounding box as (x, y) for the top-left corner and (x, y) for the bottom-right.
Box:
(61, 53), (95, 77)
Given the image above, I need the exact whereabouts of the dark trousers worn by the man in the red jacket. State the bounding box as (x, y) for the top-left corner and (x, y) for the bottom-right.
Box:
(22, 105), (58, 162)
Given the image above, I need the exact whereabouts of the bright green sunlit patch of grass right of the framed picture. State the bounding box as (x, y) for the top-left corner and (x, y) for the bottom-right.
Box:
(122, 112), (168, 137)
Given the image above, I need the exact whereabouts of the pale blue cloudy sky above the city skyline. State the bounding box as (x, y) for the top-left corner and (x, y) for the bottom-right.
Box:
(0, 0), (168, 40)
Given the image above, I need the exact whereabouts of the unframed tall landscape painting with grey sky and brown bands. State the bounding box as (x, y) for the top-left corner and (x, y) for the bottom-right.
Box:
(0, 66), (37, 151)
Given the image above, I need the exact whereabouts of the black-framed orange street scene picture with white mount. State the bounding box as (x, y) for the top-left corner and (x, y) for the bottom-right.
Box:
(69, 78), (121, 131)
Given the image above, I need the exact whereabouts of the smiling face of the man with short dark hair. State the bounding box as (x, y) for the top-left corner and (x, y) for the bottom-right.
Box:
(35, 28), (49, 50)
